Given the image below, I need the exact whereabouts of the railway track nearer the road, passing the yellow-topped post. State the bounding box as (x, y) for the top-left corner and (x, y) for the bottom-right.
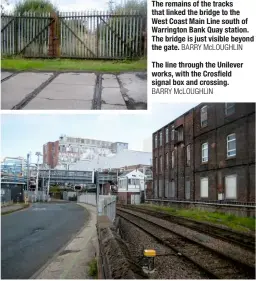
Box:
(117, 207), (255, 279)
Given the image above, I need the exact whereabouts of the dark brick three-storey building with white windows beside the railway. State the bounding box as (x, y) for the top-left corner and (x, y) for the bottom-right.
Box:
(152, 103), (255, 203)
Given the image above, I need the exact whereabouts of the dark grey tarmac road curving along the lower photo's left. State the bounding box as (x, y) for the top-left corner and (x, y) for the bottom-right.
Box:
(1, 203), (88, 279)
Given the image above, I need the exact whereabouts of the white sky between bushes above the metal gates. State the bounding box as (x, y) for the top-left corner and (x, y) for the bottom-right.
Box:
(5, 0), (132, 12)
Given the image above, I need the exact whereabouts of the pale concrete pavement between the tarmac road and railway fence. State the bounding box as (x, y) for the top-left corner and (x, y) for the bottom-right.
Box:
(33, 203), (98, 279)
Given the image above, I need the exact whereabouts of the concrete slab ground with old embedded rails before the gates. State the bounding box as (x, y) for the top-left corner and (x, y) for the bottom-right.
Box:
(1, 71), (147, 110)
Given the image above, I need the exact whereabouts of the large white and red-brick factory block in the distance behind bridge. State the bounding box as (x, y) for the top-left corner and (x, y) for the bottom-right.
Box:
(43, 135), (128, 169)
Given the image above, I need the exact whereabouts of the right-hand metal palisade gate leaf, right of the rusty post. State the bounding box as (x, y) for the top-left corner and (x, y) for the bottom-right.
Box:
(58, 12), (145, 59)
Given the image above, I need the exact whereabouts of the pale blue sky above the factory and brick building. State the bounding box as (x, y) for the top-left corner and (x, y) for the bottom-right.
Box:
(1, 103), (197, 163)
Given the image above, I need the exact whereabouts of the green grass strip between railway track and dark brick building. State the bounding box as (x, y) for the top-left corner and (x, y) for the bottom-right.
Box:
(140, 204), (255, 232)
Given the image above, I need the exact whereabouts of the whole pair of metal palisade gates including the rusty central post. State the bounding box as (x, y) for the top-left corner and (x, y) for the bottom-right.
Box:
(1, 11), (146, 59)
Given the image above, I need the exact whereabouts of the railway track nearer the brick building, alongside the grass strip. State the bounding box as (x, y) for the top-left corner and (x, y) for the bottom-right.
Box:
(120, 203), (255, 253)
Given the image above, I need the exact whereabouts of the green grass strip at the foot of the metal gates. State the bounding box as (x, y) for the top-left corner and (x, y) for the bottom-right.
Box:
(1, 58), (147, 72)
